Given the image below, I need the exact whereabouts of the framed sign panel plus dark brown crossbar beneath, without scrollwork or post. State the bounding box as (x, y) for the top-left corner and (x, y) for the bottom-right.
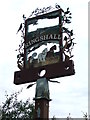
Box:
(14, 10), (75, 85)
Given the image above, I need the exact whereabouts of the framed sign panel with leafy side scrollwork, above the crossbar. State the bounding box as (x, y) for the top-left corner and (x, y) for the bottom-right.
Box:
(18, 8), (76, 69)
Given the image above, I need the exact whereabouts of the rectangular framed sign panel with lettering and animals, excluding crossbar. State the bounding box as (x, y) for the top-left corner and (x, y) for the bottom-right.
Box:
(24, 9), (62, 68)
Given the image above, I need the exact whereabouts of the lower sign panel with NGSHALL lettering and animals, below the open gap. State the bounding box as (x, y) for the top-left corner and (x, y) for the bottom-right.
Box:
(25, 25), (61, 68)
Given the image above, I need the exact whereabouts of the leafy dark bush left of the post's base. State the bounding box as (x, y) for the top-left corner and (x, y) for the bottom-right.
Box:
(1, 89), (35, 120)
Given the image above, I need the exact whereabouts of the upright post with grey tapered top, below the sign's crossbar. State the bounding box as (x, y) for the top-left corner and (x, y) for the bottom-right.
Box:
(34, 78), (50, 120)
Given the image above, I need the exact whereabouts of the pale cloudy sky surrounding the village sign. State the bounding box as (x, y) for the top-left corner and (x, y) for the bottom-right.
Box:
(0, 0), (88, 118)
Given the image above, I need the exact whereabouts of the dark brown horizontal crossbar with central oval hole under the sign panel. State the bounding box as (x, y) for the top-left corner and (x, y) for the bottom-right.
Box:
(14, 60), (75, 85)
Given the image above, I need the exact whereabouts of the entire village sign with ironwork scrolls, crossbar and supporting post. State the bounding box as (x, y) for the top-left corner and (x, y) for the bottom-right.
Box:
(14, 5), (75, 120)
